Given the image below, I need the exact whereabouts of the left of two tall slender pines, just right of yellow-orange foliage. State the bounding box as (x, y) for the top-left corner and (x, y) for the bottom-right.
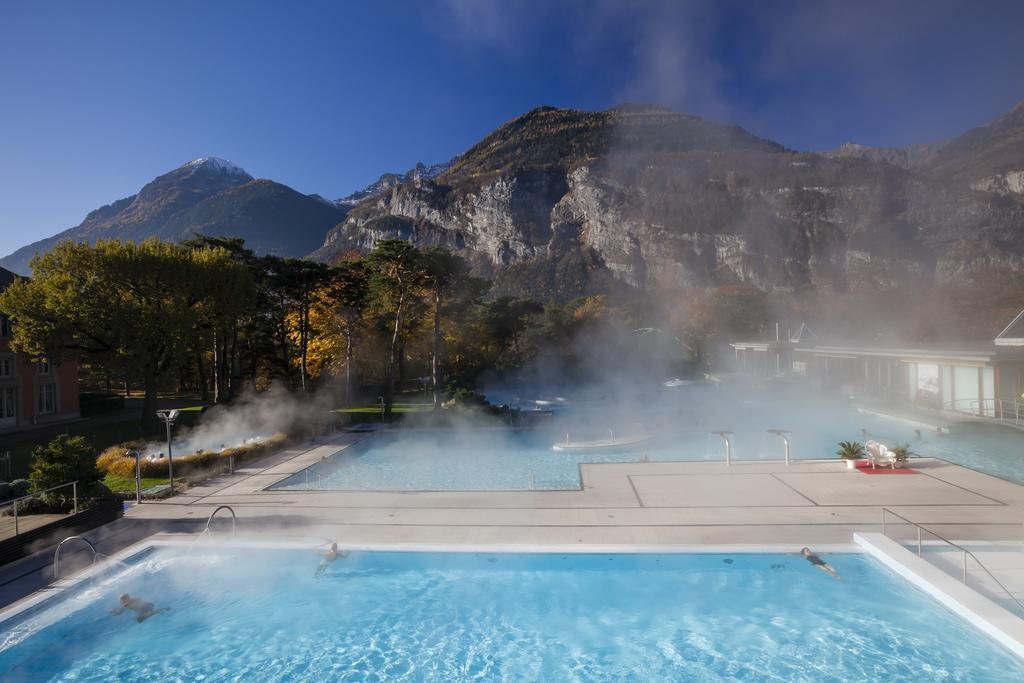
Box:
(368, 240), (425, 419)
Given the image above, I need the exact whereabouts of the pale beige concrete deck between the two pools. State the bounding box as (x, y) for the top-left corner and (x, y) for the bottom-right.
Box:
(119, 434), (1024, 546)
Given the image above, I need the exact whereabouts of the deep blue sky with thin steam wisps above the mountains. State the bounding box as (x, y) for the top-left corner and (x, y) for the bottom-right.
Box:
(0, 0), (1024, 254)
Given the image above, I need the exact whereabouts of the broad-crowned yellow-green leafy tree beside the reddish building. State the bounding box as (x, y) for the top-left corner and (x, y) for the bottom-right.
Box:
(0, 240), (236, 422)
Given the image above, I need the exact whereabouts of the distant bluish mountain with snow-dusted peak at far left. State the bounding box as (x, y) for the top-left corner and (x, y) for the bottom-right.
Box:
(0, 157), (346, 274)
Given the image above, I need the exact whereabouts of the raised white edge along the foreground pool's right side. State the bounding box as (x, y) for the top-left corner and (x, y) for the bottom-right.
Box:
(853, 531), (1024, 659)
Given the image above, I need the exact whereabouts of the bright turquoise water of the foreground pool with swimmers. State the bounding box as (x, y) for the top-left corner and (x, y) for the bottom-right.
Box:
(0, 549), (1024, 682)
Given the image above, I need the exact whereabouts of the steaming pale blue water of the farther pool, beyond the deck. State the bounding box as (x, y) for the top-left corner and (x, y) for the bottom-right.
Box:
(272, 390), (1024, 490)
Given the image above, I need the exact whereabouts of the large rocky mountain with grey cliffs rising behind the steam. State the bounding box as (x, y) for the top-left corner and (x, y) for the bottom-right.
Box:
(313, 106), (1024, 296)
